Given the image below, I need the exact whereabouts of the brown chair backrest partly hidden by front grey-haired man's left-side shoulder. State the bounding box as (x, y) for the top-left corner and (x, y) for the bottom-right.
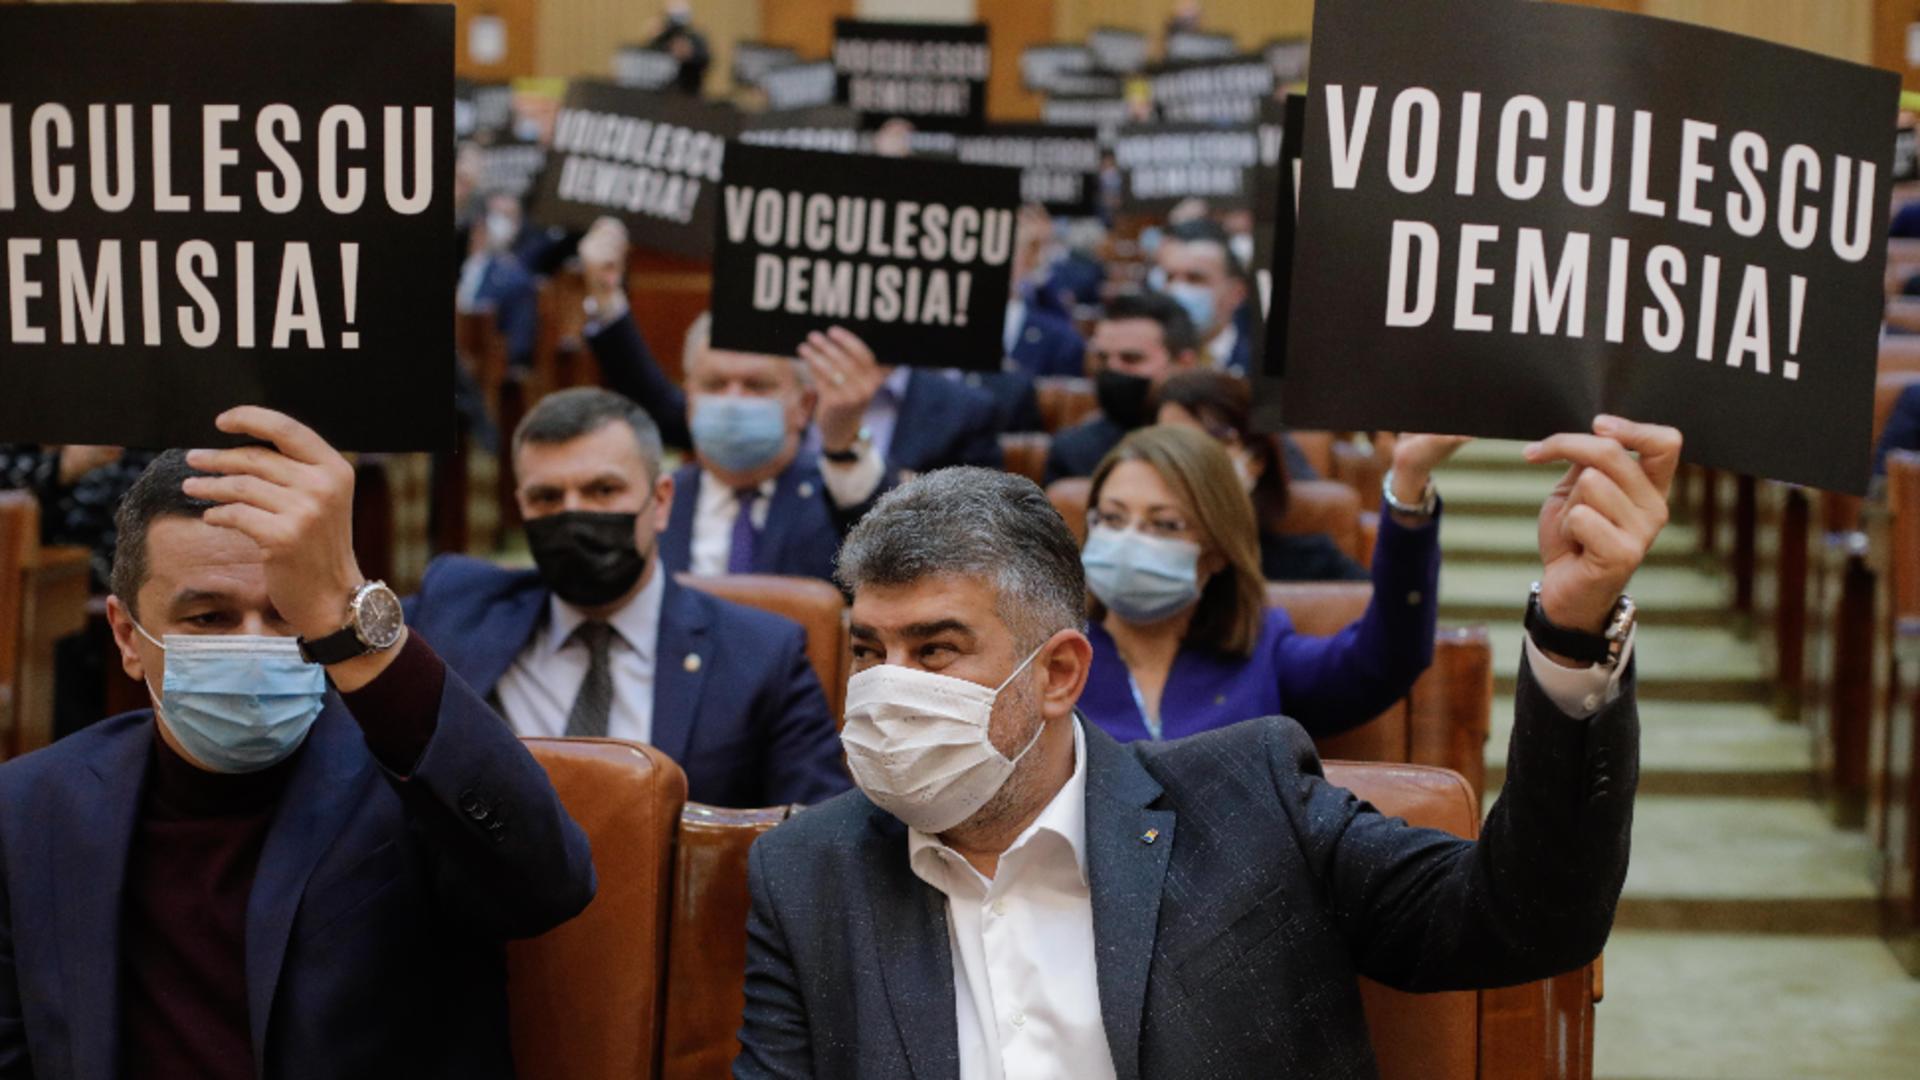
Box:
(660, 803), (799, 1080)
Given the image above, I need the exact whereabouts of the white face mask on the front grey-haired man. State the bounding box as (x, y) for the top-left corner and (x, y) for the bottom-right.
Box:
(841, 646), (1046, 834)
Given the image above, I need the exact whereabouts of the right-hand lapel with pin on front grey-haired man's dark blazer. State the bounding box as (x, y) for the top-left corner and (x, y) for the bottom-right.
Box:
(1081, 717), (1173, 1080)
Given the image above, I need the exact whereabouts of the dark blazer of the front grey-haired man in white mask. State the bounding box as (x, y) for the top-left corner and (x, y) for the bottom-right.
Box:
(733, 665), (1640, 1080)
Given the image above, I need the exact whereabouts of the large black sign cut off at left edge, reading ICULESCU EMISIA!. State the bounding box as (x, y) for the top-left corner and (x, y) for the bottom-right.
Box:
(0, 4), (455, 450)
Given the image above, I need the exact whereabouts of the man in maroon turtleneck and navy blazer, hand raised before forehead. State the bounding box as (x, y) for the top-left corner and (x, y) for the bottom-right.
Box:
(0, 407), (595, 1080)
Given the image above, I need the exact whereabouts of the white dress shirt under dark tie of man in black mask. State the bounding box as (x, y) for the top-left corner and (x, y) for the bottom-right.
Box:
(495, 561), (666, 742)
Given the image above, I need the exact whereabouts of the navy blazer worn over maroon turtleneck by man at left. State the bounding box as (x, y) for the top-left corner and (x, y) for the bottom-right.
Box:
(0, 671), (595, 1080)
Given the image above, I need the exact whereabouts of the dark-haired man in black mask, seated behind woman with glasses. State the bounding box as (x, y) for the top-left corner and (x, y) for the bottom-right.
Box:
(1046, 292), (1200, 484)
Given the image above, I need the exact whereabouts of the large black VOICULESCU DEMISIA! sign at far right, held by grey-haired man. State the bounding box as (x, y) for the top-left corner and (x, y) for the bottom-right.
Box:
(1284, 0), (1899, 492)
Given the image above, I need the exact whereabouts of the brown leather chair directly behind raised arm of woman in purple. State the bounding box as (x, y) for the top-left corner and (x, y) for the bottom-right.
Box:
(1267, 582), (1494, 794)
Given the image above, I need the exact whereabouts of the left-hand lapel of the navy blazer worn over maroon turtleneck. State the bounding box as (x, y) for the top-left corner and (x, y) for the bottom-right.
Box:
(50, 713), (156, 1080)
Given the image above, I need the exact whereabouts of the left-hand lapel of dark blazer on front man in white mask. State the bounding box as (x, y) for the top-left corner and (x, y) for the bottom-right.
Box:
(864, 807), (960, 1080)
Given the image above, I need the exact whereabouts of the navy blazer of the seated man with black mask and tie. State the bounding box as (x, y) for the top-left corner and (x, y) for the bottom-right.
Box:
(407, 555), (849, 807)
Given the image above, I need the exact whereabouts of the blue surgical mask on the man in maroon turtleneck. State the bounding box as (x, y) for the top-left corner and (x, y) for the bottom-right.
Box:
(134, 623), (326, 773)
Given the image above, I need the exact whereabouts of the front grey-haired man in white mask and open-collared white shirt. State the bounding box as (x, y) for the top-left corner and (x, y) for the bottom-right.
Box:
(733, 417), (1680, 1080)
